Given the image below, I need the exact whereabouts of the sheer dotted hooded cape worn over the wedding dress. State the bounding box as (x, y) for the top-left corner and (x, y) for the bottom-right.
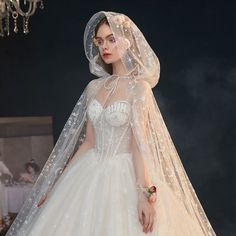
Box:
(7, 11), (216, 236)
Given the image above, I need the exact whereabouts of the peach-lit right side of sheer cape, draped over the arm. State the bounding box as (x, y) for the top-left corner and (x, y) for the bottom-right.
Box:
(131, 81), (215, 235)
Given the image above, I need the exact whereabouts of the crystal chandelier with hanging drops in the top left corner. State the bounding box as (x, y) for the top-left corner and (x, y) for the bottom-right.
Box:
(0, 0), (44, 37)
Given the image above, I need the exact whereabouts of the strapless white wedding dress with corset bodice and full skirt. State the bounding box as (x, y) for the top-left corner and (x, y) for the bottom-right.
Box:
(22, 99), (157, 236)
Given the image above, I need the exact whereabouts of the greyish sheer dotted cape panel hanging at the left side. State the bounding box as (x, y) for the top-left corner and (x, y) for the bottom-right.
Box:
(4, 79), (102, 236)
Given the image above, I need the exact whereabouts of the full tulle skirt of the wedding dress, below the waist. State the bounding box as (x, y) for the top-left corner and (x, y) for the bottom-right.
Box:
(19, 149), (205, 236)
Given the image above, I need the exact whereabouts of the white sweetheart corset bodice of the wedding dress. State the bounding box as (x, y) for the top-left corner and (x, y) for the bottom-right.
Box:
(88, 99), (131, 158)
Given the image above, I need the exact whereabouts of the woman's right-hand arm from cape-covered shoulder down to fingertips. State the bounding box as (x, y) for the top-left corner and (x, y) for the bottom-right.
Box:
(131, 82), (156, 233)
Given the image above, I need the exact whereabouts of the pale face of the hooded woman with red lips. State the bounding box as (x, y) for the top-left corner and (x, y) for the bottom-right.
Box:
(95, 24), (124, 64)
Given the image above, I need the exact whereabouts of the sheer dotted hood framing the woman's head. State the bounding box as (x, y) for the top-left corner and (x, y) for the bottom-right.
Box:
(84, 11), (160, 87)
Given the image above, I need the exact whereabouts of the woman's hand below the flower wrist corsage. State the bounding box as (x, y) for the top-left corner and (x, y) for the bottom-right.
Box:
(138, 198), (156, 233)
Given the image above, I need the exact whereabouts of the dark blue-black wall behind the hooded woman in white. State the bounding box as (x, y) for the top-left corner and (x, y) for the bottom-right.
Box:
(0, 0), (236, 236)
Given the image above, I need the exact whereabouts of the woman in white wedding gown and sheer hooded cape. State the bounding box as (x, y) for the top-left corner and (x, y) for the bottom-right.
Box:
(7, 12), (215, 236)
